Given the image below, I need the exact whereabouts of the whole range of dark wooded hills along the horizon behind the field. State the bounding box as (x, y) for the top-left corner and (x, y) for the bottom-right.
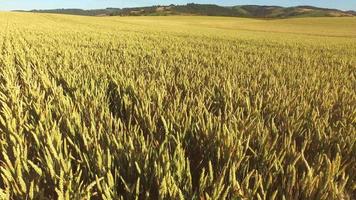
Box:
(25, 3), (356, 18)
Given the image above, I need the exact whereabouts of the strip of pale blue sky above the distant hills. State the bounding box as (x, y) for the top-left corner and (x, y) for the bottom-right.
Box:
(0, 0), (356, 10)
